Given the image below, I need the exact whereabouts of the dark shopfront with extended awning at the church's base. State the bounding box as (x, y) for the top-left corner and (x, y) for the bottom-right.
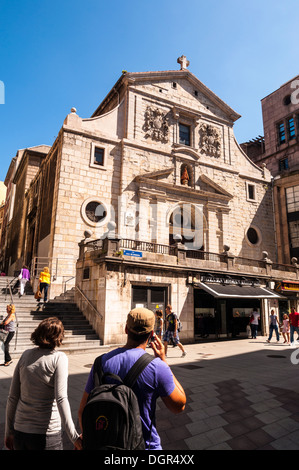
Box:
(194, 275), (281, 338)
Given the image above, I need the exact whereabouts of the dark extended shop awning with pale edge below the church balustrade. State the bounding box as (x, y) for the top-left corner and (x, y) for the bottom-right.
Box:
(194, 282), (285, 299)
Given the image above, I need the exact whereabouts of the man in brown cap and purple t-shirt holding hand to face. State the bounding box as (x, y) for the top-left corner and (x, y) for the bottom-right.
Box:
(79, 308), (186, 450)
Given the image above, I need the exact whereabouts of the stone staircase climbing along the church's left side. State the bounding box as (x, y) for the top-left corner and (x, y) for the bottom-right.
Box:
(0, 276), (101, 358)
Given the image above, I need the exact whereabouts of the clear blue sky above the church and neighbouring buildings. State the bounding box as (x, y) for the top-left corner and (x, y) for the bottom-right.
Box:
(0, 0), (299, 181)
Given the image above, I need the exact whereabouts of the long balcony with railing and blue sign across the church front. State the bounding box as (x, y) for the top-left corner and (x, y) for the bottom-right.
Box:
(80, 238), (299, 281)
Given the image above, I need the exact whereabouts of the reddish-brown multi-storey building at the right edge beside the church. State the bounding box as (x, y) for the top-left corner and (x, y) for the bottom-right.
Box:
(242, 75), (299, 312)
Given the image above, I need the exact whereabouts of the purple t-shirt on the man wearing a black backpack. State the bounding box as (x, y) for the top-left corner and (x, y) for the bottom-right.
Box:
(85, 348), (175, 450)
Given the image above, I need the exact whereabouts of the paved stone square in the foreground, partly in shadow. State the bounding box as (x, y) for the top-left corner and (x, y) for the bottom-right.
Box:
(0, 337), (299, 451)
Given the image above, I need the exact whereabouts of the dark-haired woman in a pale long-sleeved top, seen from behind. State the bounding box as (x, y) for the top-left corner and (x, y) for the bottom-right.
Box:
(5, 317), (82, 450)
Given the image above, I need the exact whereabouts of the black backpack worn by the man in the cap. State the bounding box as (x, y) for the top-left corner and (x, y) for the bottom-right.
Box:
(82, 353), (155, 450)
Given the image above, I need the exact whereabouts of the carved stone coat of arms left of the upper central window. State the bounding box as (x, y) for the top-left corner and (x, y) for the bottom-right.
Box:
(144, 106), (169, 142)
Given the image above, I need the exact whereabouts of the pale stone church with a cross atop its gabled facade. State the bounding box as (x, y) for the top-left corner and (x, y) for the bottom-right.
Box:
(3, 56), (298, 344)
